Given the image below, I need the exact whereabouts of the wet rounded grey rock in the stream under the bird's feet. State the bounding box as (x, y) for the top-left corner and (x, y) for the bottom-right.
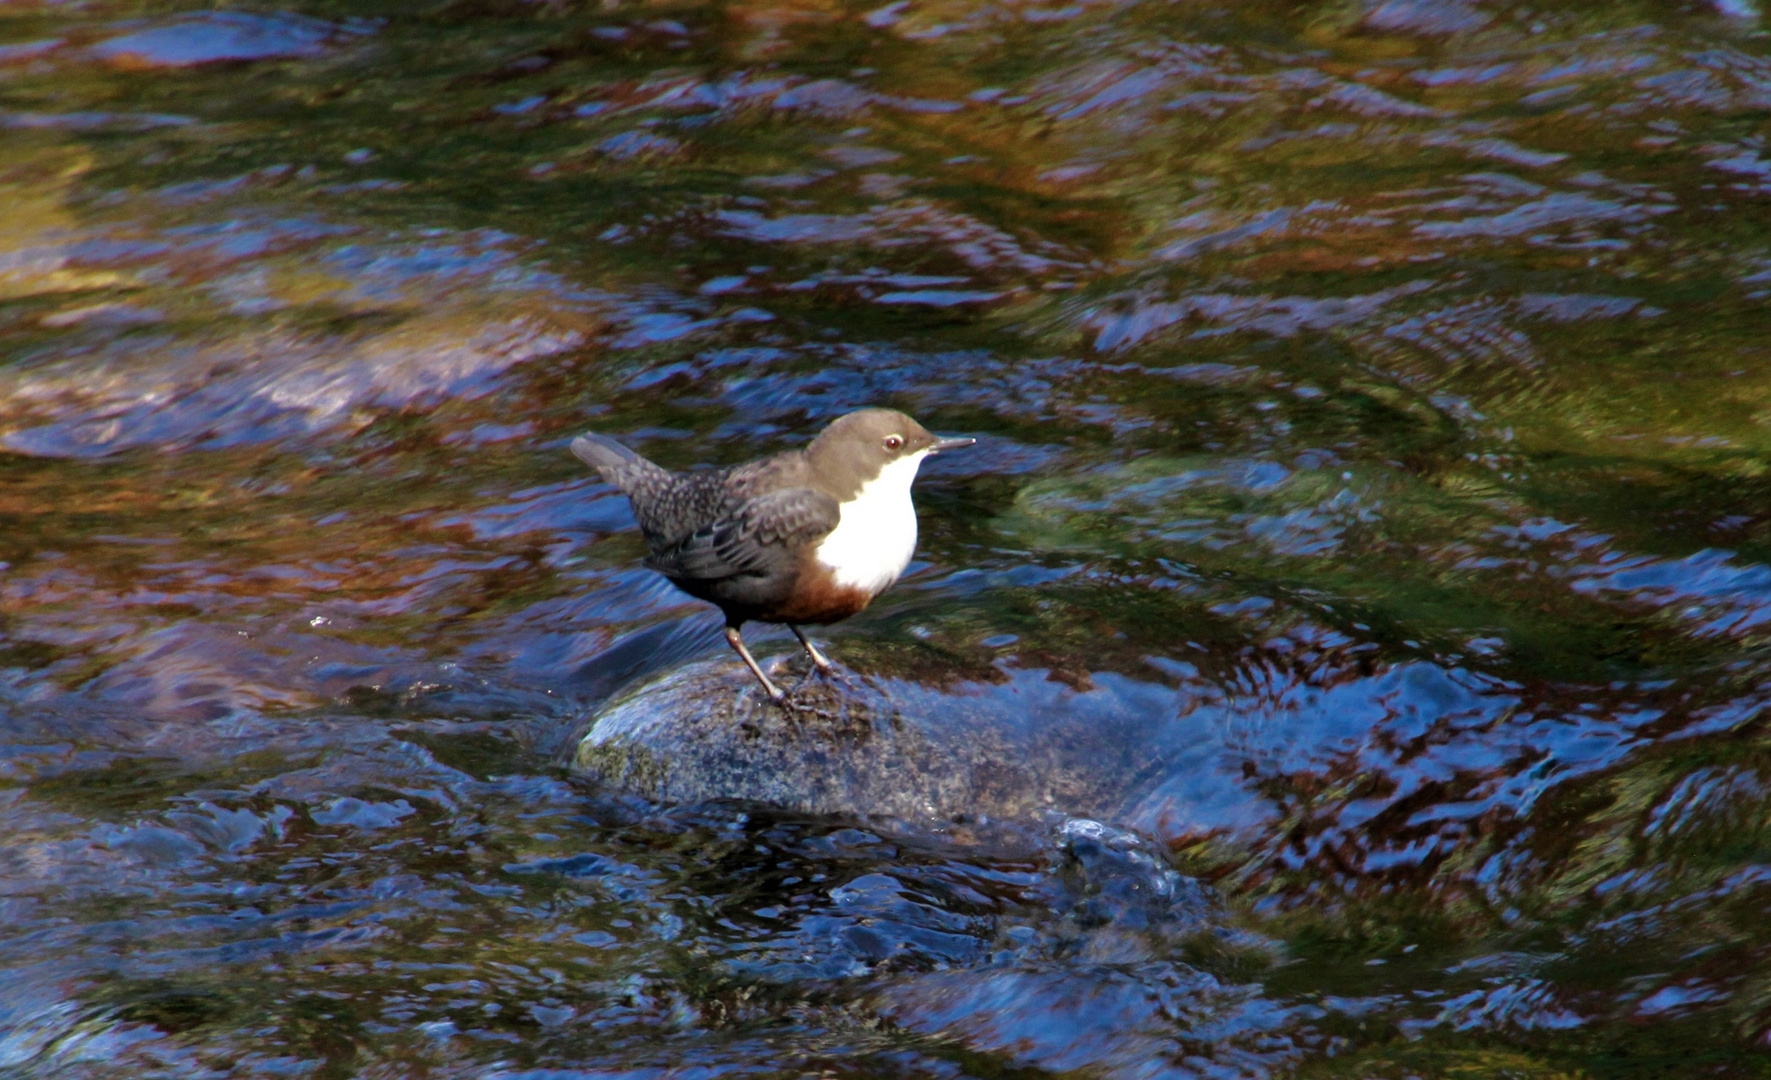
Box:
(574, 660), (1172, 822)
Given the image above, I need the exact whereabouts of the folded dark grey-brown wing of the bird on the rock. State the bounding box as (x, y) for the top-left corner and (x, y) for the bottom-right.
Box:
(646, 487), (843, 581)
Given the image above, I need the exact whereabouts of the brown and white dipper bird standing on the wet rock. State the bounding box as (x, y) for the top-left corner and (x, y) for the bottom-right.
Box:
(572, 409), (976, 703)
